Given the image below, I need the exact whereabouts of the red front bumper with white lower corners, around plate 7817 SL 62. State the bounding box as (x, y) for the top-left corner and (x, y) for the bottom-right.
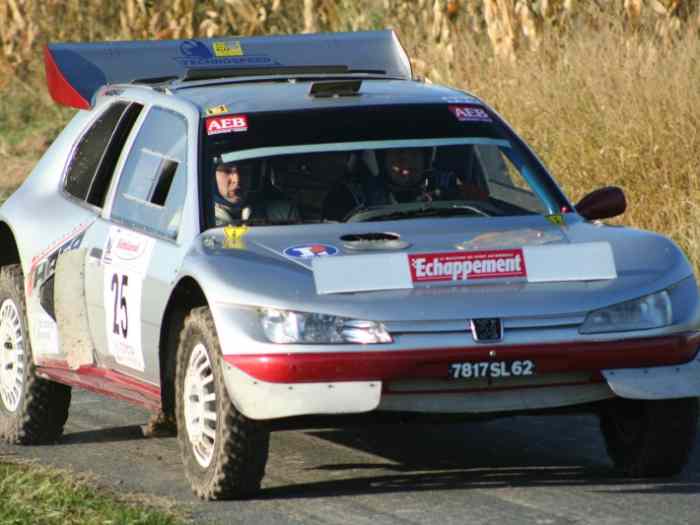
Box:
(223, 332), (700, 419)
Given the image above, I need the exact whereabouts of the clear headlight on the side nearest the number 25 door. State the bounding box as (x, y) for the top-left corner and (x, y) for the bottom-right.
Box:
(260, 308), (392, 344)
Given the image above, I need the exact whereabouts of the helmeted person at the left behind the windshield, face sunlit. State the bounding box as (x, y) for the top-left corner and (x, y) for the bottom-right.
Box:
(214, 162), (252, 226)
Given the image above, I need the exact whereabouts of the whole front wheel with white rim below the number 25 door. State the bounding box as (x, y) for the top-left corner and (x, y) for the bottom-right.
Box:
(176, 307), (270, 500)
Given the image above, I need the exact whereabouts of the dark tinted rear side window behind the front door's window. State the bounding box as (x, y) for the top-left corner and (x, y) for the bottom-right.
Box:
(64, 101), (142, 207)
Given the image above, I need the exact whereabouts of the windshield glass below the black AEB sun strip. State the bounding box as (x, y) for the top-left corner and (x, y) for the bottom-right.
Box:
(198, 103), (566, 226)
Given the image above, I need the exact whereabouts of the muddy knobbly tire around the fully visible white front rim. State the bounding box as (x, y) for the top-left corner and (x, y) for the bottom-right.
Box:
(175, 306), (270, 500)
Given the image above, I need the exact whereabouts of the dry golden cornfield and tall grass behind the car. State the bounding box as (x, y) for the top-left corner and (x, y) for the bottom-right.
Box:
(0, 0), (700, 268)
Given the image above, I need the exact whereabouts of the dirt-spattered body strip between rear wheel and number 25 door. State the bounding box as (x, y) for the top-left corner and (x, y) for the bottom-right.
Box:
(54, 248), (94, 369)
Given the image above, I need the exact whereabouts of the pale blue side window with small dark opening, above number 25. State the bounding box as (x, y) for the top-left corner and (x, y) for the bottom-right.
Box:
(112, 107), (187, 239)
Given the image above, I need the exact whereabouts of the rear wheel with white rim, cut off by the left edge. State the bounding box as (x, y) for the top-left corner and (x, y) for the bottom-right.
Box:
(0, 265), (71, 445)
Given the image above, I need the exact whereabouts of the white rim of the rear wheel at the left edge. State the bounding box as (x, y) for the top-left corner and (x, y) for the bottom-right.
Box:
(0, 299), (24, 412)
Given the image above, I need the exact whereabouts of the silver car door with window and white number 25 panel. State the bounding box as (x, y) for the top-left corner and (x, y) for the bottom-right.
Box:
(85, 106), (194, 384)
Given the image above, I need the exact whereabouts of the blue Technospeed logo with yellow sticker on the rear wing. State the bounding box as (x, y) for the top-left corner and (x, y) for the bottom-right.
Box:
(174, 40), (280, 68)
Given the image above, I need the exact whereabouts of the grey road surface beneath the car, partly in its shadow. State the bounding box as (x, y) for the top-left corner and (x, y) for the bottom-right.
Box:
(0, 390), (700, 525)
